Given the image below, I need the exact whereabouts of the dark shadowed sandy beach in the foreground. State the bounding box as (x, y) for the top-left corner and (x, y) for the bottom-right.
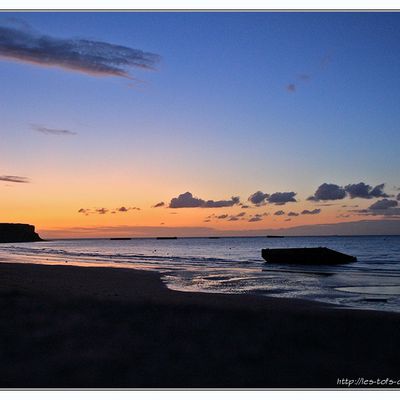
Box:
(0, 263), (400, 389)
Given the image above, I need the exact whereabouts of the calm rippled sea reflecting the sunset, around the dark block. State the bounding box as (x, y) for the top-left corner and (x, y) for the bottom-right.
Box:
(0, 236), (400, 312)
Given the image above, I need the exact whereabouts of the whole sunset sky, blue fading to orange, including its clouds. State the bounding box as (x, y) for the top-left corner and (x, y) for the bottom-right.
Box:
(0, 12), (400, 238)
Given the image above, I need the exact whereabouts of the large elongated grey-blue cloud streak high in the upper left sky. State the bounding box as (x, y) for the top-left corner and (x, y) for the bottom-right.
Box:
(0, 26), (160, 79)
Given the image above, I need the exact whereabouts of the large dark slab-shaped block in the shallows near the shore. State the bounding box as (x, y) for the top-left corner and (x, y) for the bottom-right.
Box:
(261, 247), (357, 265)
